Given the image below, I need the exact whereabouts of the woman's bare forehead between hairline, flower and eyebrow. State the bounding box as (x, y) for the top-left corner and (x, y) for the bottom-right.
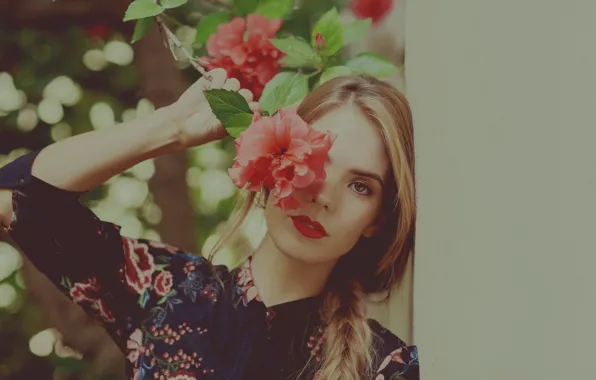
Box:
(312, 104), (389, 177)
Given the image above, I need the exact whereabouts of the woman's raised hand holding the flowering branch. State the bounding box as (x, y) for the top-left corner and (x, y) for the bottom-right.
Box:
(166, 69), (258, 148)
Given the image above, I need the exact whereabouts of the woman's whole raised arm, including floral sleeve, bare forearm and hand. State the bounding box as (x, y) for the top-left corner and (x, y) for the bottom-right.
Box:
(0, 67), (248, 349)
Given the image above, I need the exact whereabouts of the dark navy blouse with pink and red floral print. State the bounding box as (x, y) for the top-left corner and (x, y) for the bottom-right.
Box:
(0, 151), (420, 380)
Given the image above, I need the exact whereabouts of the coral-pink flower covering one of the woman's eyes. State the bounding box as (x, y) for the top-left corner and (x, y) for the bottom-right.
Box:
(229, 109), (335, 211)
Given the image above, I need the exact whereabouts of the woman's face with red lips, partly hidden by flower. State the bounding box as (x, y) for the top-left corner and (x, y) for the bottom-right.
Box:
(265, 104), (389, 263)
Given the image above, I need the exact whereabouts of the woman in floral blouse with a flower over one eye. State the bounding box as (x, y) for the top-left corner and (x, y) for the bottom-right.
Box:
(0, 69), (419, 380)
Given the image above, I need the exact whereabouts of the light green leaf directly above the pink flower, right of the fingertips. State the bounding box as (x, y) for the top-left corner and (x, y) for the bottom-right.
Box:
(259, 72), (308, 115)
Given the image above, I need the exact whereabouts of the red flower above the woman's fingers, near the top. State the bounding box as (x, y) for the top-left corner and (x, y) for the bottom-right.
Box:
(202, 14), (283, 100)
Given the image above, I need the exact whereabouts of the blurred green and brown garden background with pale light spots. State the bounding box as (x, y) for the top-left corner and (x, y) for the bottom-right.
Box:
(0, 0), (411, 380)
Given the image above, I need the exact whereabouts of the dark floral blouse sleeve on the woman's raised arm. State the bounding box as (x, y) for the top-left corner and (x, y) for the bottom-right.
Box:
(0, 151), (187, 350)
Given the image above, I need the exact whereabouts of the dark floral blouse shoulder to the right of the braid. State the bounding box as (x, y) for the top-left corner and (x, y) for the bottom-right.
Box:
(369, 319), (420, 380)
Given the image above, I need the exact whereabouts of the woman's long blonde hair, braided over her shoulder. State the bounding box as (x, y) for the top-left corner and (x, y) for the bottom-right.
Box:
(209, 76), (416, 380)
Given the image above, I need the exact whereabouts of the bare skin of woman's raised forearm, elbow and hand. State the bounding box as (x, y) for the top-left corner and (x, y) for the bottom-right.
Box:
(0, 69), (244, 226)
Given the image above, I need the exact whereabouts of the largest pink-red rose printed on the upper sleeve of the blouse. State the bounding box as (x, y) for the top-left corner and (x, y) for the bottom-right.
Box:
(122, 237), (155, 294)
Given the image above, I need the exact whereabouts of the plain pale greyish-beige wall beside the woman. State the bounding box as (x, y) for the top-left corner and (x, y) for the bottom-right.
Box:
(406, 0), (596, 380)
